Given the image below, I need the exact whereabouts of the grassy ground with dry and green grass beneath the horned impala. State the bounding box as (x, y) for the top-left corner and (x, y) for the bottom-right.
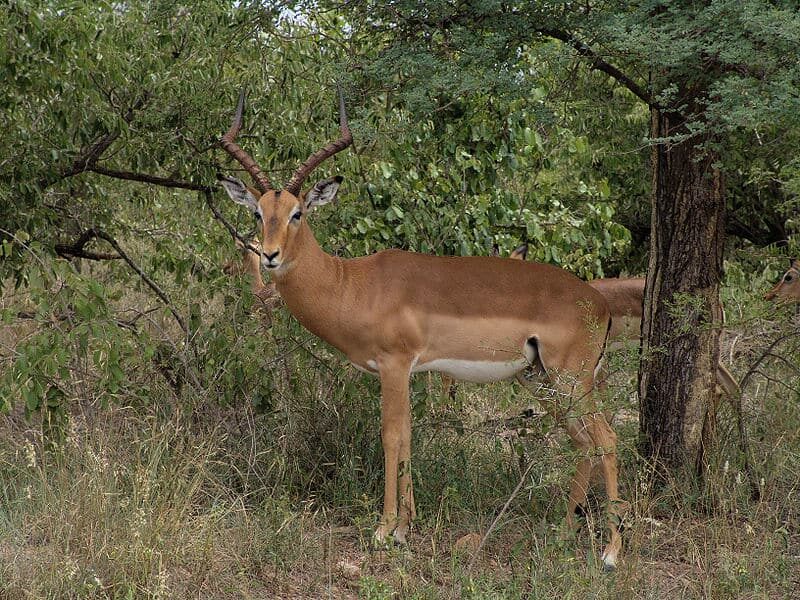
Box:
(0, 260), (800, 599)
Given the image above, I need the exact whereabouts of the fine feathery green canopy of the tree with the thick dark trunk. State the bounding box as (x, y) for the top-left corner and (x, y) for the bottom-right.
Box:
(340, 0), (800, 251)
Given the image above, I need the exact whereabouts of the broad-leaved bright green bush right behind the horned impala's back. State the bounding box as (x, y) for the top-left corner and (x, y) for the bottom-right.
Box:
(332, 89), (629, 276)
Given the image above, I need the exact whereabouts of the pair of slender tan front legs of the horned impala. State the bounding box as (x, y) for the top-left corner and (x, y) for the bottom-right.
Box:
(375, 362), (416, 543)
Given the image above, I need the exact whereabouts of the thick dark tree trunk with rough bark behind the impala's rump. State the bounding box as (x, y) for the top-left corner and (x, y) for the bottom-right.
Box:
(639, 109), (725, 469)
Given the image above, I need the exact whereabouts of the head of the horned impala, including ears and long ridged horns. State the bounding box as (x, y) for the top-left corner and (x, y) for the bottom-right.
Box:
(219, 90), (353, 271)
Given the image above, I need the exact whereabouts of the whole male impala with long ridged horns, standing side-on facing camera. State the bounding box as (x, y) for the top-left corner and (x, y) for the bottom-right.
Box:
(220, 89), (624, 568)
